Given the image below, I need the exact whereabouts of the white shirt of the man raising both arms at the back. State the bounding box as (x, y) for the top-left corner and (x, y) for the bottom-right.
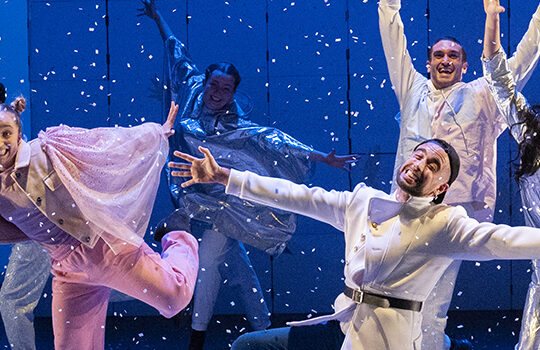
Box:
(379, 0), (540, 221)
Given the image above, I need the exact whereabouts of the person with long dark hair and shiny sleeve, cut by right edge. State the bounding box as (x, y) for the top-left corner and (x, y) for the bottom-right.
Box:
(483, 0), (540, 350)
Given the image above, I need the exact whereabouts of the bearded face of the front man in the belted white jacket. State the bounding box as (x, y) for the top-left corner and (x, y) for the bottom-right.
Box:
(396, 142), (450, 197)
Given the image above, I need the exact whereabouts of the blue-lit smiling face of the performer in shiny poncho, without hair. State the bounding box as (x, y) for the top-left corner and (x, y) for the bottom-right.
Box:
(203, 70), (236, 111)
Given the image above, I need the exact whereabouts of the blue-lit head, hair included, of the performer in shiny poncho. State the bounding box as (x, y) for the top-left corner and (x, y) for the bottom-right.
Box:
(202, 63), (241, 111)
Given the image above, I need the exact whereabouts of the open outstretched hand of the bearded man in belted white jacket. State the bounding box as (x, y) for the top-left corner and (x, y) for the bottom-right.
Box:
(169, 146), (230, 187)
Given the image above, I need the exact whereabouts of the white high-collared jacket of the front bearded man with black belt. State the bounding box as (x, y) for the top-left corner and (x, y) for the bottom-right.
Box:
(226, 170), (540, 350)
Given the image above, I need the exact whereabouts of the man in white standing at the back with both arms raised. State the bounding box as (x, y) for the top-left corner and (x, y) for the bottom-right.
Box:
(379, 0), (540, 350)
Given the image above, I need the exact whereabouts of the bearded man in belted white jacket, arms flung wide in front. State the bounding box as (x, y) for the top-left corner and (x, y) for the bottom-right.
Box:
(169, 139), (540, 350)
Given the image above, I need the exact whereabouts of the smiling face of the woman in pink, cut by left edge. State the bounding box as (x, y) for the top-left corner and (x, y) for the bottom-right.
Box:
(0, 111), (21, 172)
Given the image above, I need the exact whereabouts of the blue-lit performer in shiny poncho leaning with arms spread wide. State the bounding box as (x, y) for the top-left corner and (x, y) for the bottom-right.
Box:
(140, 0), (355, 350)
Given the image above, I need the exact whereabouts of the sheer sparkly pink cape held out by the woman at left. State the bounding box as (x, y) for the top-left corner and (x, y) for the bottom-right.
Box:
(38, 123), (169, 246)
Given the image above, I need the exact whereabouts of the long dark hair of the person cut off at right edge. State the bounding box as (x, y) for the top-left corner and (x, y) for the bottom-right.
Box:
(512, 105), (540, 181)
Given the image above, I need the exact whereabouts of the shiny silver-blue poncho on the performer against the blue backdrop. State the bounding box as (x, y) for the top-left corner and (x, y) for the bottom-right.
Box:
(164, 37), (314, 255)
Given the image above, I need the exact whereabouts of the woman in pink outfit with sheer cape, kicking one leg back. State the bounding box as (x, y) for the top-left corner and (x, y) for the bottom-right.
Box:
(0, 97), (198, 350)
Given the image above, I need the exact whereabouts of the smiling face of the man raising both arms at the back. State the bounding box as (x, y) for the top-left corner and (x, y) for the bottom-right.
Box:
(427, 40), (468, 89)
